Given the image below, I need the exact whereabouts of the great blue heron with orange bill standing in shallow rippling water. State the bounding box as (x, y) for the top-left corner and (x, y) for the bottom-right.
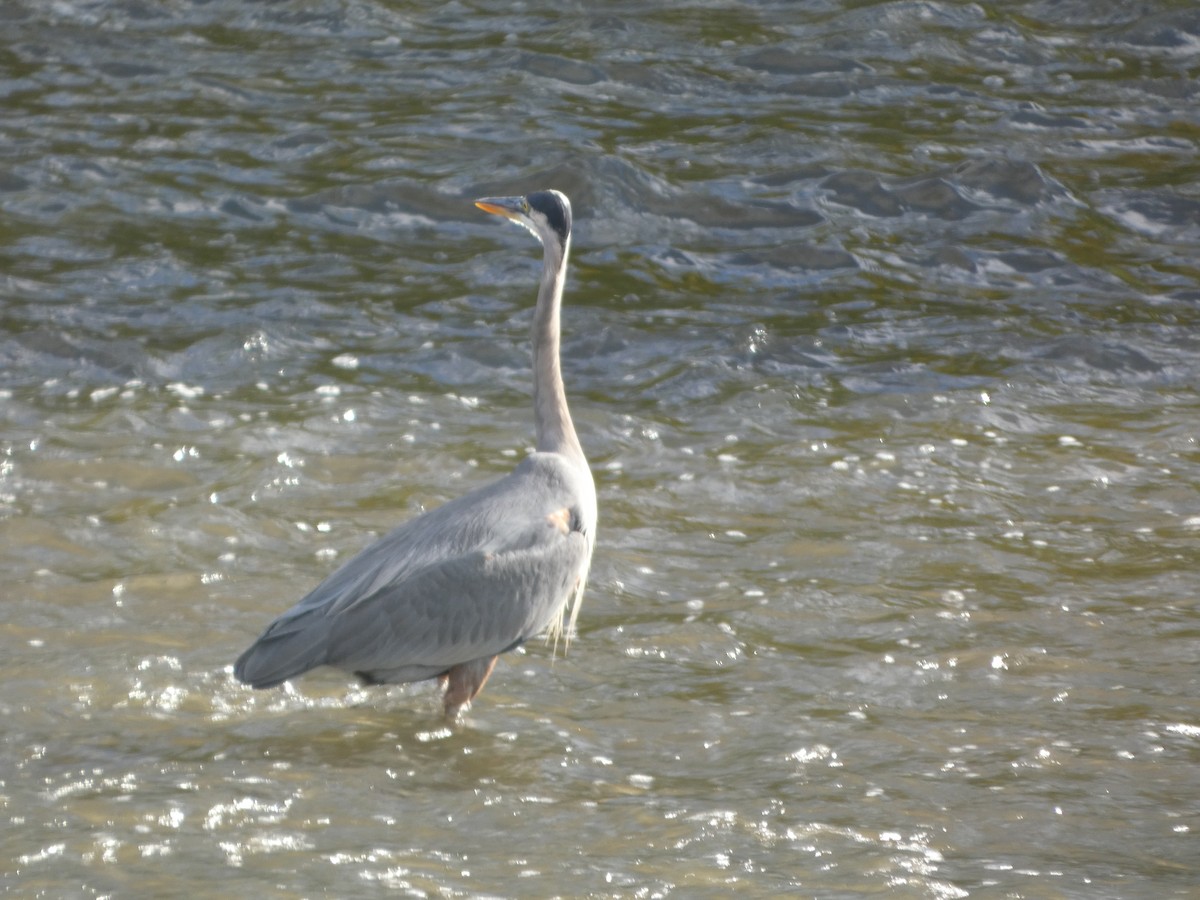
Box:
(234, 191), (596, 719)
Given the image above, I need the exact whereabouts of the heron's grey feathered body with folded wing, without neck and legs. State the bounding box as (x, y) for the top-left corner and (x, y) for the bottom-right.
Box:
(234, 454), (592, 688)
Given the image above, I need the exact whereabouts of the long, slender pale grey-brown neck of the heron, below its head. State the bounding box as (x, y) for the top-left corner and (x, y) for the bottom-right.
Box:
(530, 239), (584, 461)
